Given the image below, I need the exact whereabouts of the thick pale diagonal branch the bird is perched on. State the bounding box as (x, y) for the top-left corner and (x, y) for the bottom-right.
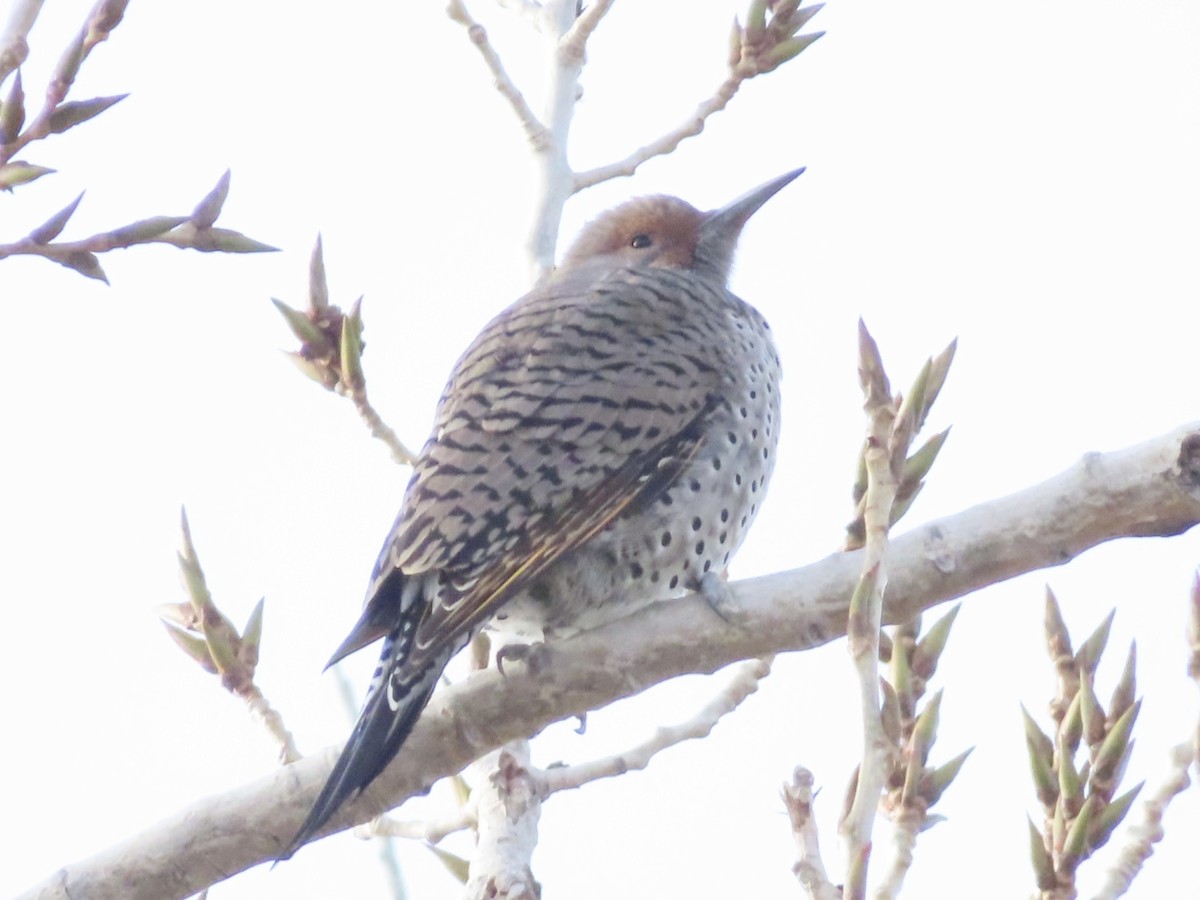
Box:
(23, 422), (1200, 900)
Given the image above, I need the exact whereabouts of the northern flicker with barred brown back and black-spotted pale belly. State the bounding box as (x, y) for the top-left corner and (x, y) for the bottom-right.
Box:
(278, 169), (804, 859)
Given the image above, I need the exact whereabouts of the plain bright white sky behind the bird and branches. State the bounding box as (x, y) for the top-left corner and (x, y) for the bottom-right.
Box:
(7, 0), (1200, 900)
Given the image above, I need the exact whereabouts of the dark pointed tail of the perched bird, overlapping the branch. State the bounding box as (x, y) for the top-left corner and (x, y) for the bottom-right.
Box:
(276, 622), (450, 862)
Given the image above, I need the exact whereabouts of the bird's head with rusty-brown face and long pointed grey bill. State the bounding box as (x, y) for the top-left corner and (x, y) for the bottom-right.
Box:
(560, 168), (804, 281)
